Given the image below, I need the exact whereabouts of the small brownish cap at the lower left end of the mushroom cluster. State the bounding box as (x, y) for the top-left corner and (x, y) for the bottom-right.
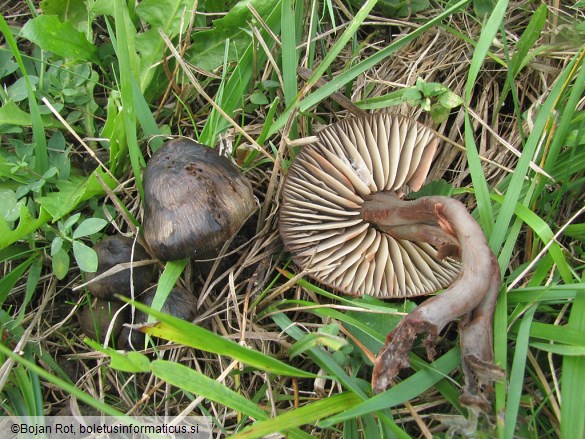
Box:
(79, 299), (128, 343)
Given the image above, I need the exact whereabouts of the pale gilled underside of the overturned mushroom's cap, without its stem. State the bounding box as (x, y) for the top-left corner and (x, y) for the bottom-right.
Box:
(279, 113), (460, 298)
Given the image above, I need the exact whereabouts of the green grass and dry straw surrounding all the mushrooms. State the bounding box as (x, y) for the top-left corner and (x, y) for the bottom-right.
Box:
(0, 0), (585, 439)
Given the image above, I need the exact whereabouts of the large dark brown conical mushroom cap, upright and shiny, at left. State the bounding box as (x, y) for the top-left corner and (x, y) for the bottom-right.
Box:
(143, 138), (256, 261)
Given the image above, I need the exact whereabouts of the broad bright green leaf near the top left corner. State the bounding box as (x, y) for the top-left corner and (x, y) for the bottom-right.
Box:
(21, 15), (99, 64)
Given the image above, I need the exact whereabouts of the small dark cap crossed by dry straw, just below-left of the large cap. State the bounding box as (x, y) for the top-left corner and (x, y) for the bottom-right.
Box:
(87, 235), (153, 300)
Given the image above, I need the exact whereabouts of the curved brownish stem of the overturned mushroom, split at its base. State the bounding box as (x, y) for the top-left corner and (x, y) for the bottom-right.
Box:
(361, 192), (500, 407)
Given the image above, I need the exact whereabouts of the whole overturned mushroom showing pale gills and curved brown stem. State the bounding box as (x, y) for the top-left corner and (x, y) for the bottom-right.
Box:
(279, 113), (500, 411)
